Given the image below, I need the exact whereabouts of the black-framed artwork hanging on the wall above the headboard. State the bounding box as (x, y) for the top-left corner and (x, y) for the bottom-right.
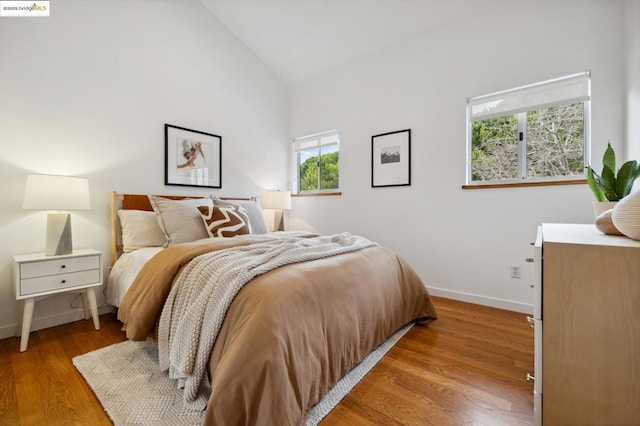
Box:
(164, 124), (222, 188)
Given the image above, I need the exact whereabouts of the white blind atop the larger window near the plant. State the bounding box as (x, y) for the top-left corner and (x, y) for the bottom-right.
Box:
(468, 71), (591, 121)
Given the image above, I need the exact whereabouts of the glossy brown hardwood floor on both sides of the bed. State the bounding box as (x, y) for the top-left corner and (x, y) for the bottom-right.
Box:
(0, 297), (533, 426)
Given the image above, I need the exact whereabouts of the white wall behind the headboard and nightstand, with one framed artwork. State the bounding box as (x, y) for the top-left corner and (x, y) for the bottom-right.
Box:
(0, 0), (288, 338)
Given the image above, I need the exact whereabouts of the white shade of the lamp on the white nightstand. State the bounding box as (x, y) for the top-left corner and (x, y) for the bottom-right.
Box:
(22, 175), (91, 210)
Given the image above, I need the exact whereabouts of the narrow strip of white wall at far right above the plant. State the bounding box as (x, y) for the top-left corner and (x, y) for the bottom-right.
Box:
(624, 0), (640, 161)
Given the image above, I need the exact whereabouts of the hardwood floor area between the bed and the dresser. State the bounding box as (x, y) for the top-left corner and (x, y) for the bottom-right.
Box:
(323, 297), (533, 426)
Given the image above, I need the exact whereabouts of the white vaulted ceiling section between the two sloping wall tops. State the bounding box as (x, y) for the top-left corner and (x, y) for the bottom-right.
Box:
(200, 0), (482, 84)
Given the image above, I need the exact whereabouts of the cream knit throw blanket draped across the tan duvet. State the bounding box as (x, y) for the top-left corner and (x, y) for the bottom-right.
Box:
(158, 233), (376, 410)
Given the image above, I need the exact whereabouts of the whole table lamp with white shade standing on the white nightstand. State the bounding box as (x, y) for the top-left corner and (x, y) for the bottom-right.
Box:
(22, 175), (91, 256)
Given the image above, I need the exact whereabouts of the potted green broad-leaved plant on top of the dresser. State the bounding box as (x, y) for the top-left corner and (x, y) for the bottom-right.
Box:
(587, 143), (640, 217)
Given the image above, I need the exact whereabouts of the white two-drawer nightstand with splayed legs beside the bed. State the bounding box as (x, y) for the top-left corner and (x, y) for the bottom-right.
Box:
(13, 249), (102, 352)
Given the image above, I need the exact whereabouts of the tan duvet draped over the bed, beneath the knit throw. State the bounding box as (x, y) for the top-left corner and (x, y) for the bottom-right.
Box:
(118, 238), (436, 425)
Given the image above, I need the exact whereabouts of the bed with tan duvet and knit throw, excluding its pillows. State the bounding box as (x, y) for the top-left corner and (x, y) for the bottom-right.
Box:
(108, 194), (436, 425)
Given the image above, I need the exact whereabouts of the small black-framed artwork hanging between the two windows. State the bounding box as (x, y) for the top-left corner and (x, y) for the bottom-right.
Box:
(371, 129), (411, 188)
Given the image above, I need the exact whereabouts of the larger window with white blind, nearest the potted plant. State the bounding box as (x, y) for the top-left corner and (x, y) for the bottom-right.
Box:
(467, 72), (590, 185)
